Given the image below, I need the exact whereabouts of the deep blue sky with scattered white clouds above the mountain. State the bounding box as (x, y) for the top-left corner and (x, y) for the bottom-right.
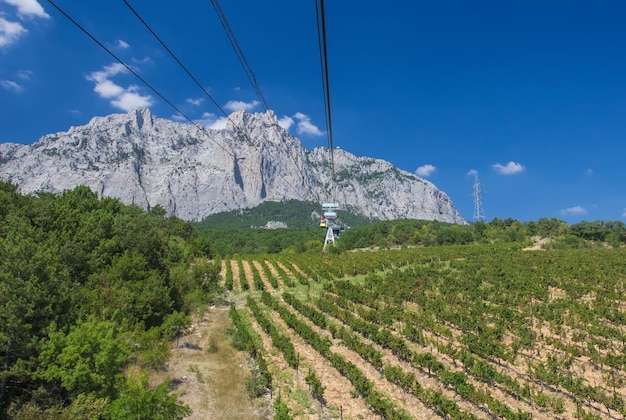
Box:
(0, 0), (626, 223)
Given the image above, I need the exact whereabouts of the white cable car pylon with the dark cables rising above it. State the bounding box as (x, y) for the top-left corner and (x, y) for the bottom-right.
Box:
(315, 0), (342, 252)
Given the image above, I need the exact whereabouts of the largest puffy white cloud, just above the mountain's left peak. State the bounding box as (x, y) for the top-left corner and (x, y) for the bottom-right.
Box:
(87, 63), (154, 111)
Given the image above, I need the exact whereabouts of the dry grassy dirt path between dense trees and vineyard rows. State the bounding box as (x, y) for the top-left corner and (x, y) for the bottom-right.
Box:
(153, 307), (272, 420)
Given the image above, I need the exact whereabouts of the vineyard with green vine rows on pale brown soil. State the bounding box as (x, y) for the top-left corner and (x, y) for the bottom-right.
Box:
(221, 244), (626, 419)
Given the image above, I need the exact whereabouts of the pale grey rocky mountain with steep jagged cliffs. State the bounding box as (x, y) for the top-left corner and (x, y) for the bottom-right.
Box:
(0, 108), (465, 223)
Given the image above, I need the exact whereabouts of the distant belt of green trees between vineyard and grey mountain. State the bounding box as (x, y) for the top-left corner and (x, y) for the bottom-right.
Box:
(194, 200), (626, 257)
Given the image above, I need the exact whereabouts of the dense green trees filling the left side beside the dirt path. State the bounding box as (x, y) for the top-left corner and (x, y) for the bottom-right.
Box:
(0, 182), (219, 419)
